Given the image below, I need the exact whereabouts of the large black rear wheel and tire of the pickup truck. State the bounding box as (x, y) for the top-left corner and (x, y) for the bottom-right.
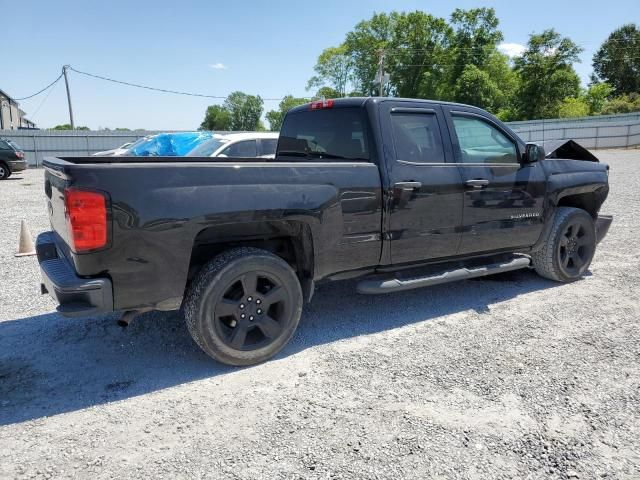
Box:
(184, 247), (303, 366)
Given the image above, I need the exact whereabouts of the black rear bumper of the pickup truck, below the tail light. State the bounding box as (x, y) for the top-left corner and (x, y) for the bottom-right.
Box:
(36, 232), (113, 317)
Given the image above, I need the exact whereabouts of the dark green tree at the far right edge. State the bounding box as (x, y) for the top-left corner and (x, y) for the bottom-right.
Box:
(593, 23), (640, 95)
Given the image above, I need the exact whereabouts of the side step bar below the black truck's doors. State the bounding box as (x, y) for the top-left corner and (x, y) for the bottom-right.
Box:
(357, 256), (531, 294)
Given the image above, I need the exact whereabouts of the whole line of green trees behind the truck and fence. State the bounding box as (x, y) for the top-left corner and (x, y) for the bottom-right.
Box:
(201, 8), (640, 130)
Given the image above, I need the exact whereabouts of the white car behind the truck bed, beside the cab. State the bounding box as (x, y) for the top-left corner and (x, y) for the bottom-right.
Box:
(187, 132), (279, 158)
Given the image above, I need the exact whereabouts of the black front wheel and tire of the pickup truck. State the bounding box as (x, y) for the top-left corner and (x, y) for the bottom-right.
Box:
(531, 207), (596, 283)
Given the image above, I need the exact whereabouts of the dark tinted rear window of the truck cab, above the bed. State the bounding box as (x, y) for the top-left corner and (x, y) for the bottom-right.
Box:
(277, 108), (370, 161)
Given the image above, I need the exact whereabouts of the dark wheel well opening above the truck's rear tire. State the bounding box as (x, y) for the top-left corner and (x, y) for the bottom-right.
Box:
(188, 222), (313, 282)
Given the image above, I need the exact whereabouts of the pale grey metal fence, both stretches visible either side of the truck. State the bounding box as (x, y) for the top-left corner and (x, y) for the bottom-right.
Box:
(0, 112), (640, 166)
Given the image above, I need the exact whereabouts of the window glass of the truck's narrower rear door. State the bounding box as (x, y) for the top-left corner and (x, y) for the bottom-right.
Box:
(391, 113), (444, 163)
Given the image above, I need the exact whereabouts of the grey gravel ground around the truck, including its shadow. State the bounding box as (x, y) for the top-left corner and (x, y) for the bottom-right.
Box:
(0, 150), (640, 479)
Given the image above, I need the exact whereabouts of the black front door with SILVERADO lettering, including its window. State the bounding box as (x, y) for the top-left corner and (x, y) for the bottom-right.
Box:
(444, 106), (546, 255)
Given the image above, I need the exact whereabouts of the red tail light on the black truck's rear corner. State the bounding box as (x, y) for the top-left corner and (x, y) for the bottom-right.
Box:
(64, 188), (107, 253)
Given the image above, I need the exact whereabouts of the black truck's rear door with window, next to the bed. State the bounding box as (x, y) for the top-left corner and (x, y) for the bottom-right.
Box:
(380, 102), (463, 264)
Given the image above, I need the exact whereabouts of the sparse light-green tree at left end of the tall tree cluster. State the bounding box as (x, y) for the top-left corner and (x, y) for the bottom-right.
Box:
(307, 45), (354, 97)
